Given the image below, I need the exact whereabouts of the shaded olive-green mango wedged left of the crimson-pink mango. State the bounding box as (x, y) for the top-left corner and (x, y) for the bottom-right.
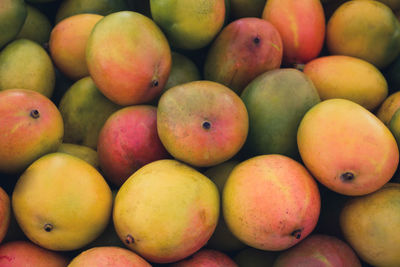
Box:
(58, 77), (121, 150)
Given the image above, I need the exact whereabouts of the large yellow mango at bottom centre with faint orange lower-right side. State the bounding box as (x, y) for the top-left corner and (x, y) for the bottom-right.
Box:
(113, 159), (220, 263)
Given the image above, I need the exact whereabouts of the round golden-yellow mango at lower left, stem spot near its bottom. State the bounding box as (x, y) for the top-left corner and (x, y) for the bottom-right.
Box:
(11, 153), (112, 251)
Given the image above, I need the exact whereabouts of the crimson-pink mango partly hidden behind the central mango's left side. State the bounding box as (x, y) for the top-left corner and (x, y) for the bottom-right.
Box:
(97, 105), (170, 187)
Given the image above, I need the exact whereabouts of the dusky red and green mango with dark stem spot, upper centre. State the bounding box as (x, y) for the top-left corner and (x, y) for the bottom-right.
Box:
(204, 18), (283, 94)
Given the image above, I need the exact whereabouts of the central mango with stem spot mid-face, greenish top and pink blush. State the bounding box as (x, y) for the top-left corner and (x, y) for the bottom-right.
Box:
(157, 81), (249, 167)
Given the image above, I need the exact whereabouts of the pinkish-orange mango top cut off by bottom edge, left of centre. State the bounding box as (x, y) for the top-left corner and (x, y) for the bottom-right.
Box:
(68, 246), (151, 267)
